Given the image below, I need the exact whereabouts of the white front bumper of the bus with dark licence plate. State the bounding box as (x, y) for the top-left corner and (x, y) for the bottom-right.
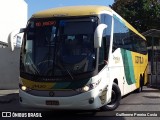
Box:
(19, 89), (102, 110)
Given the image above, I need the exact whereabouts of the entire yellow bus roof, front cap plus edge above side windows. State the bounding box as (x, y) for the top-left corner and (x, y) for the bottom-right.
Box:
(32, 5), (146, 40)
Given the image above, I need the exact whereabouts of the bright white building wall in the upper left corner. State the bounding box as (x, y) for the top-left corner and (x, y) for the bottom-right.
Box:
(0, 0), (28, 43)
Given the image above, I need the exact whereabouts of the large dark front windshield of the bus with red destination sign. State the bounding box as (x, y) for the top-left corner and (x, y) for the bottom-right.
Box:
(21, 17), (97, 78)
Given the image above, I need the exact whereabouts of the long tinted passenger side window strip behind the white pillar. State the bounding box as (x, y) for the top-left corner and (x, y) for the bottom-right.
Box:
(112, 18), (147, 54)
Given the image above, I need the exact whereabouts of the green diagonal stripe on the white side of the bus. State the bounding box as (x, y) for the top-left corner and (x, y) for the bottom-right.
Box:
(121, 49), (136, 85)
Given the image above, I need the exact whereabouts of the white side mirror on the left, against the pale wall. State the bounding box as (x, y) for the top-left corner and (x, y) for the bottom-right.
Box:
(9, 28), (26, 51)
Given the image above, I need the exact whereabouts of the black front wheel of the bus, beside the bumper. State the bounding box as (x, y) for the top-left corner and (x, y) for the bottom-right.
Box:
(102, 83), (121, 111)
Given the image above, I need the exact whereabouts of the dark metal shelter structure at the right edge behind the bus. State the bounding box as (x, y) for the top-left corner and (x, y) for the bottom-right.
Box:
(143, 29), (160, 88)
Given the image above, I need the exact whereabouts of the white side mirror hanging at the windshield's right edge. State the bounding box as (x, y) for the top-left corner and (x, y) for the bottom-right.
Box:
(94, 24), (107, 48)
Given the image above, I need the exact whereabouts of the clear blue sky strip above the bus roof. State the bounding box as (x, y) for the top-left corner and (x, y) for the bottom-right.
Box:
(25, 0), (114, 19)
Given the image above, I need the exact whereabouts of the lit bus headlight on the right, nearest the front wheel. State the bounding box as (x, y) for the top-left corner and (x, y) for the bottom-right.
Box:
(76, 79), (101, 92)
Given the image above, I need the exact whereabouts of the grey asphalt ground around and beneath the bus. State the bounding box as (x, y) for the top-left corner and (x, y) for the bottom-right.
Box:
(0, 87), (160, 120)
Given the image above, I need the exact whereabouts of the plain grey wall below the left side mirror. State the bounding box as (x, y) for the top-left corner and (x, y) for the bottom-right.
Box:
(0, 48), (20, 90)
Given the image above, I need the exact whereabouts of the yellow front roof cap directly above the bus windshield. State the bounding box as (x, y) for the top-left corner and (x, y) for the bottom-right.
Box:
(32, 5), (112, 18)
